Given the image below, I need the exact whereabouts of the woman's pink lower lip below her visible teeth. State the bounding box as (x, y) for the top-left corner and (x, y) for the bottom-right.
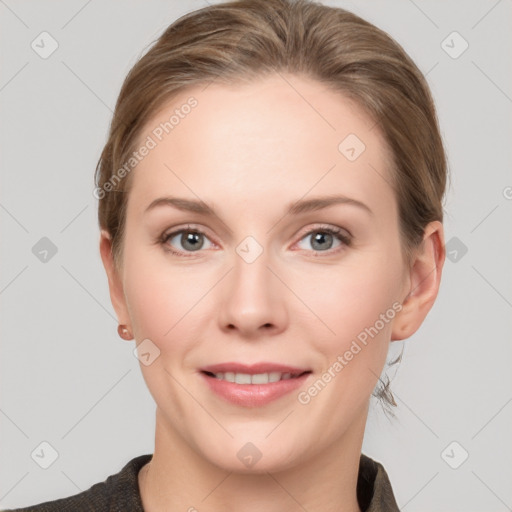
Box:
(201, 372), (311, 407)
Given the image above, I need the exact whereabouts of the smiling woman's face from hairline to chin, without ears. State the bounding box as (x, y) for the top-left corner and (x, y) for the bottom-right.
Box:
(107, 75), (410, 471)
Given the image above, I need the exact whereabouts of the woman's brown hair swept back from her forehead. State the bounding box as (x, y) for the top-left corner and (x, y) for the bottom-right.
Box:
(95, 0), (447, 416)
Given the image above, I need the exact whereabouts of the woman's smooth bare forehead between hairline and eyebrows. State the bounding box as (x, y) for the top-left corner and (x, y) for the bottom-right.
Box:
(129, 74), (393, 219)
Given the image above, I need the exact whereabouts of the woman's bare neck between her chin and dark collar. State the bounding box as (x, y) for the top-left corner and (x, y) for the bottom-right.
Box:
(139, 407), (368, 512)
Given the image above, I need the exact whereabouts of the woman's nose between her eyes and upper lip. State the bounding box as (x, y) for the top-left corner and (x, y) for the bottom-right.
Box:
(217, 244), (290, 339)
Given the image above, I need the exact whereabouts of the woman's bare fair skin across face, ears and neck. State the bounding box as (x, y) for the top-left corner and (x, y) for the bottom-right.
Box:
(100, 75), (444, 512)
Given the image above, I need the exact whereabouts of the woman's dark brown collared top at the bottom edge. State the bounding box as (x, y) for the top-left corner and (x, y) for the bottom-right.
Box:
(2, 454), (400, 512)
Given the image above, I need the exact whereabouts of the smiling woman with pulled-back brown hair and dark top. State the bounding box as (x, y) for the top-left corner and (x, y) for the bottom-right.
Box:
(4, 0), (446, 512)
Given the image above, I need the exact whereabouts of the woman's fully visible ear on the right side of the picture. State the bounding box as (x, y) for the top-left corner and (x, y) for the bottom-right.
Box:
(391, 221), (445, 341)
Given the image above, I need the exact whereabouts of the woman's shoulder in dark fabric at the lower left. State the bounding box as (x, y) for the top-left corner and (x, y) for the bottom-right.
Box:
(1, 454), (152, 512)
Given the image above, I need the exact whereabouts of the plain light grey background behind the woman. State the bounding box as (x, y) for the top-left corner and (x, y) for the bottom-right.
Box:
(0, 0), (512, 512)
